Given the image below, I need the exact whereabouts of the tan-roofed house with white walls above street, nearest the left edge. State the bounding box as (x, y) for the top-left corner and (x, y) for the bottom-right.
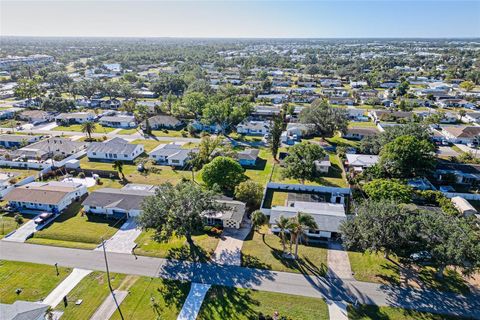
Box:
(4, 181), (87, 213)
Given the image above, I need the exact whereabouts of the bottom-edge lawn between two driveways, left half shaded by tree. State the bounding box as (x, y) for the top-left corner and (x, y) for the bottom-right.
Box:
(198, 286), (329, 320)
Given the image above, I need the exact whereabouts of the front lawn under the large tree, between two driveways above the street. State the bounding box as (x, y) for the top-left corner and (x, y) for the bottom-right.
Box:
(135, 230), (219, 262)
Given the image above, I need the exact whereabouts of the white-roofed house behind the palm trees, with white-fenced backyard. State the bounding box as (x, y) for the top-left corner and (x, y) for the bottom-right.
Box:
(269, 201), (347, 239)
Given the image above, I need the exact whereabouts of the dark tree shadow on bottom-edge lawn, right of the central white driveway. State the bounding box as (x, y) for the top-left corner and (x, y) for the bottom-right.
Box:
(199, 286), (260, 319)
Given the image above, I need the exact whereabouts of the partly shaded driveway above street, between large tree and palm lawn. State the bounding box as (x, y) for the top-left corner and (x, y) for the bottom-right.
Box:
(212, 228), (251, 266)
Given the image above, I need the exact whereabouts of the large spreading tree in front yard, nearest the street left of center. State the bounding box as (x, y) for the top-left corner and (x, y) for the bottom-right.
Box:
(137, 181), (223, 244)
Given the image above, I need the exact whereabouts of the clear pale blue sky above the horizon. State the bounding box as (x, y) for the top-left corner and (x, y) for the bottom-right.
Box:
(0, 0), (480, 38)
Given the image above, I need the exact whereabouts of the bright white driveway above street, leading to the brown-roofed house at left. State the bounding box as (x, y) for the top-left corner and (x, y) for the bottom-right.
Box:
(95, 218), (142, 254)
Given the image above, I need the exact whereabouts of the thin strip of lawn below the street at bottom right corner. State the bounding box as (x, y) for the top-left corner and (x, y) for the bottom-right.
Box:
(347, 305), (459, 320)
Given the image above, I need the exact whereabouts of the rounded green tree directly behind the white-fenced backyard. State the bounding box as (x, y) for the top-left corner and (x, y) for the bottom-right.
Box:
(283, 142), (325, 183)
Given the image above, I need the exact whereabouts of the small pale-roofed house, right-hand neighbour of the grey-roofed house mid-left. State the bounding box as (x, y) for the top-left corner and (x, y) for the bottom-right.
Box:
(148, 143), (198, 167)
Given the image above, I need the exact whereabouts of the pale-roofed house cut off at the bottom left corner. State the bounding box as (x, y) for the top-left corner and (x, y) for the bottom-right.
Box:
(0, 300), (50, 320)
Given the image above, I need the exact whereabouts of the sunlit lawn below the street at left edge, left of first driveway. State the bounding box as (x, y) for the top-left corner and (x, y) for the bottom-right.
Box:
(0, 260), (72, 303)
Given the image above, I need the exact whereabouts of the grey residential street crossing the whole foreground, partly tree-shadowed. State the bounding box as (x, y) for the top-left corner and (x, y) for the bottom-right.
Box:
(0, 241), (480, 319)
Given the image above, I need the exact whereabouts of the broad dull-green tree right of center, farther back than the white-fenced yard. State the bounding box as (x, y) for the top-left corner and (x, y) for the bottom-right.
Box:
(300, 100), (348, 138)
